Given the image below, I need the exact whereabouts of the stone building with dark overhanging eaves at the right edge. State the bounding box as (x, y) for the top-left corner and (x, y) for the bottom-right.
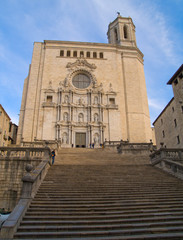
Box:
(153, 65), (183, 148)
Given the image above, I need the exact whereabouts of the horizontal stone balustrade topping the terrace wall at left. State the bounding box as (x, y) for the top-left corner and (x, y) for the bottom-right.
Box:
(0, 147), (50, 160)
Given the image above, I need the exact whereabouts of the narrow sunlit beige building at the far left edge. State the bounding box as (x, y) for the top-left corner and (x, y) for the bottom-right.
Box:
(0, 104), (11, 146)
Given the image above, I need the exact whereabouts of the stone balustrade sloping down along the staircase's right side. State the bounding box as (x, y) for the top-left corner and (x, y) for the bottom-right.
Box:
(150, 148), (183, 180)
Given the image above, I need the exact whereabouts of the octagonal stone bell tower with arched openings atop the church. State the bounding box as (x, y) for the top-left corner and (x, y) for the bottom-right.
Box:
(107, 13), (137, 47)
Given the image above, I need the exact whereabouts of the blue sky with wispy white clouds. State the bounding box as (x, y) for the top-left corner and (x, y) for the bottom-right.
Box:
(0, 0), (183, 124)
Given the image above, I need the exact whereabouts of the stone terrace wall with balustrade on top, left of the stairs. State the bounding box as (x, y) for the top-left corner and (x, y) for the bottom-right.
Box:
(0, 147), (50, 211)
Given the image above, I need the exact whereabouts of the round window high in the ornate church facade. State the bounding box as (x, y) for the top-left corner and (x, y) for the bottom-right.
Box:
(72, 73), (91, 88)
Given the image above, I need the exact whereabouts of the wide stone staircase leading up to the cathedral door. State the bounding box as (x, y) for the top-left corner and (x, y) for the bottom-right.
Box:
(14, 149), (183, 240)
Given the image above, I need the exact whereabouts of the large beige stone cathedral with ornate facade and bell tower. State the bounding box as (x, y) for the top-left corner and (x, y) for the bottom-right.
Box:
(17, 15), (152, 147)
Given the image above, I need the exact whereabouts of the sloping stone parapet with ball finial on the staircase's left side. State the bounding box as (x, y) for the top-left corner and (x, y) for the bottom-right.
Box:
(0, 157), (50, 239)
